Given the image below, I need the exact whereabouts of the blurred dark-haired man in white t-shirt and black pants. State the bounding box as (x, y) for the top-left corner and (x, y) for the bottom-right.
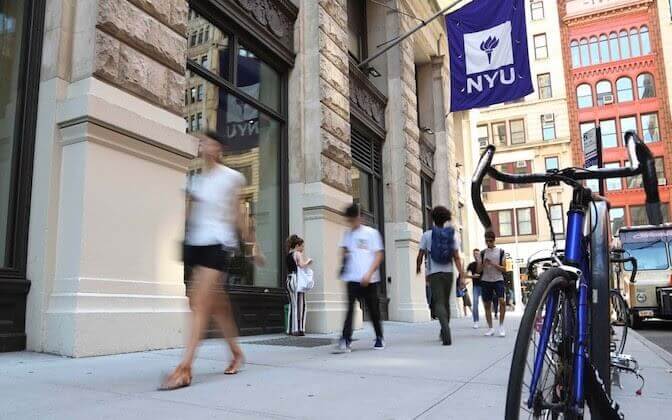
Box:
(337, 204), (385, 353)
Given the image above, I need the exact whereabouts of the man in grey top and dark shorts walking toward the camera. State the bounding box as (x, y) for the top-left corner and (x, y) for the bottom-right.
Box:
(477, 231), (506, 337)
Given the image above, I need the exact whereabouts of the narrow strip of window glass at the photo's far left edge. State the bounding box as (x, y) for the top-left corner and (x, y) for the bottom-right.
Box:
(0, 1), (25, 267)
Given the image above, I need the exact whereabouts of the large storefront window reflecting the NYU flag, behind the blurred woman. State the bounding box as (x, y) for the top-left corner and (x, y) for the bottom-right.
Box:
(185, 8), (286, 287)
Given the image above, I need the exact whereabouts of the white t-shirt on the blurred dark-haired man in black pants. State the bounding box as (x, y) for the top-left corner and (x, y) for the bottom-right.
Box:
(339, 225), (383, 283)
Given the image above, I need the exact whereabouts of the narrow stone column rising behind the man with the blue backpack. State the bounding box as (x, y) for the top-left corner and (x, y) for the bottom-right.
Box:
(383, 14), (429, 322)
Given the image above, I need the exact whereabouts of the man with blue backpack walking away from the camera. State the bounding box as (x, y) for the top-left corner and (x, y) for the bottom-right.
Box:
(416, 206), (462, 346)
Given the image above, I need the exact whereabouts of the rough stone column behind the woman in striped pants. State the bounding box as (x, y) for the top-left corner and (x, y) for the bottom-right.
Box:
(289, 0), (352, 332)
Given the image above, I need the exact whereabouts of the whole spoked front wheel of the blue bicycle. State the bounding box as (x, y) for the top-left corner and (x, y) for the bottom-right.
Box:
(505, 268), (578, 420)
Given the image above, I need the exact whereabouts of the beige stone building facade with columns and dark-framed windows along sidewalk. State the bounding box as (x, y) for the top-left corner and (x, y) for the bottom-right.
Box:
(0, 0), (464, 356)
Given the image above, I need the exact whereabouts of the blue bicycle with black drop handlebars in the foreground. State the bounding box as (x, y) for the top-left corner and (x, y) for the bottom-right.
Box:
(471, 132), (662, 420)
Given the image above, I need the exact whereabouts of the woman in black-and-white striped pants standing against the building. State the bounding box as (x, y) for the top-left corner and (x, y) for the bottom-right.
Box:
(286, 235), (313, 336)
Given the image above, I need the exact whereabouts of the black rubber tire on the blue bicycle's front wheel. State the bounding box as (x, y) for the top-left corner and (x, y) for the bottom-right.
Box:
(505, 268), (582, 420)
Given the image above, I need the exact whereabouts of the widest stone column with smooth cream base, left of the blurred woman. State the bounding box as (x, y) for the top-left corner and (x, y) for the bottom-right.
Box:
(27, 0), (196, 356)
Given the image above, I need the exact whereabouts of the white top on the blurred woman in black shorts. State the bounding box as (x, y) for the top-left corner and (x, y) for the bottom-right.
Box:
(185, 165), (245, 247)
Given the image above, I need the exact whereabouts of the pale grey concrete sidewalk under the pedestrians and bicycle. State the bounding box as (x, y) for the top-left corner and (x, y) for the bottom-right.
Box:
(0, 319), (672, 420)
